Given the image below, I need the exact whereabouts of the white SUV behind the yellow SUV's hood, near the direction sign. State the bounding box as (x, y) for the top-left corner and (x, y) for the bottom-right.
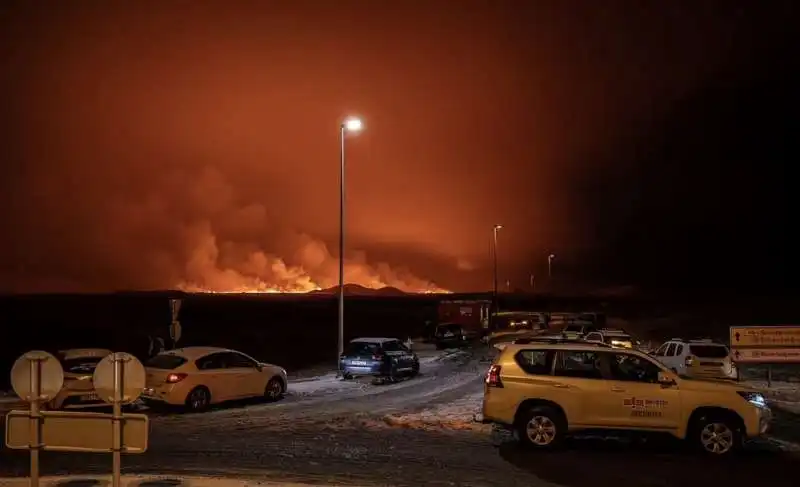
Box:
(653, 338), (737, 379)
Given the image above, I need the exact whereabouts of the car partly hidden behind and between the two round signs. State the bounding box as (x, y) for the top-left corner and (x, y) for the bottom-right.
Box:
(47, 348), (112, 409)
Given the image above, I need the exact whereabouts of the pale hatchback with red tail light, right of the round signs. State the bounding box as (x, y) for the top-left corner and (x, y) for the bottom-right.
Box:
(142, 347), (288, 411)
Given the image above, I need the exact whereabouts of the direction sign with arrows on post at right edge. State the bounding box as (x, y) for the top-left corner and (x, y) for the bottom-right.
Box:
(730, 326), (800, 387)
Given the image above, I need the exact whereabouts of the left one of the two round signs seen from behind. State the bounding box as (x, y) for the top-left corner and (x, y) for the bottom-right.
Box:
(11, 350), (64, 402)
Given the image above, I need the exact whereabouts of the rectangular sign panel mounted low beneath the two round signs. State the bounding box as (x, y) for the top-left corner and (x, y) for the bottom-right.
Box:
(6, 411), (149, 453)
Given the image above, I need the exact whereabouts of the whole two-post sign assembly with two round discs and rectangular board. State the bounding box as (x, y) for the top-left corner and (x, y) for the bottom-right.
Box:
(5, 351), (149, 487)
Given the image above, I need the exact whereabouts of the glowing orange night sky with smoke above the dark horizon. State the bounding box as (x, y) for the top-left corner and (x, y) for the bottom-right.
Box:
(0, 0), (800, 292)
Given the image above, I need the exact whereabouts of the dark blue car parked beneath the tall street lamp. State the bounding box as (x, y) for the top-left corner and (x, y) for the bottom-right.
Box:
(339, 338), (419, 381)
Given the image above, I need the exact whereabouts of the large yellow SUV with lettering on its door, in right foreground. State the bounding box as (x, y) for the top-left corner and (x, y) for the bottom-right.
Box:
(482, 342), (771, 455)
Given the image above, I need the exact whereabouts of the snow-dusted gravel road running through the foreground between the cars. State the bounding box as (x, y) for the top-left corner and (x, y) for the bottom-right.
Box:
(0, 352), (798, 487)
